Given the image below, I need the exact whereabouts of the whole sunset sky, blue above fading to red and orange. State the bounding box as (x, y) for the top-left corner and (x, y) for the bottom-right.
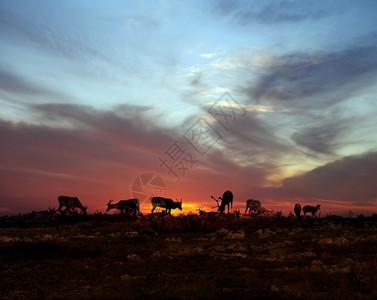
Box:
(0, 0), (377, 216)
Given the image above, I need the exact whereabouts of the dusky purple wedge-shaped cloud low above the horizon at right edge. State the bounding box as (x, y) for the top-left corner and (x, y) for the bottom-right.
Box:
(261, 152), (377, 206)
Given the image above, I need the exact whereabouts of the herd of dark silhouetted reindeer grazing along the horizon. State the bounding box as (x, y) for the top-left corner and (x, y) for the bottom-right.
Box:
(50, 191), (321, 218)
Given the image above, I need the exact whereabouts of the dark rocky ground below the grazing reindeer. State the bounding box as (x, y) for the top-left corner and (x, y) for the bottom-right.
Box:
(0, 214), (377, 299)
